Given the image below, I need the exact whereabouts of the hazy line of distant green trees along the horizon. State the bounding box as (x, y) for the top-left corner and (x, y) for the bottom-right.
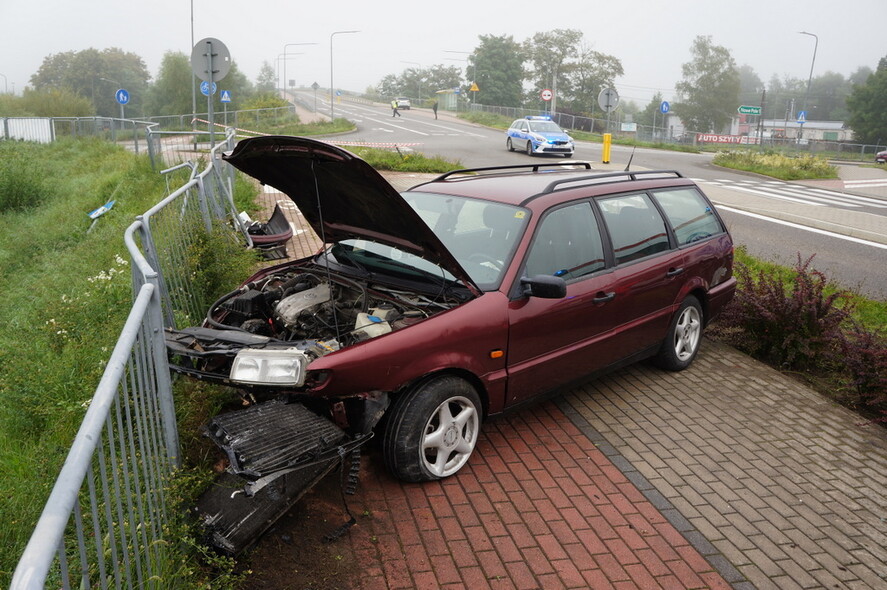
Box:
(0, 37), (887, 143)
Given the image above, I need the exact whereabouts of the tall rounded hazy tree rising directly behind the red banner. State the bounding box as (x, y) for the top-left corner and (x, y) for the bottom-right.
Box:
(674, 35), (740, 132)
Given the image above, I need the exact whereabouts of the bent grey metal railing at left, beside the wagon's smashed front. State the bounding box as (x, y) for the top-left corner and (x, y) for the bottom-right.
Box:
(11, 132), (243, 590)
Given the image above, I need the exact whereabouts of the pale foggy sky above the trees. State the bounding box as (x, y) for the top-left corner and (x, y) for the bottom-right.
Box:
(0, 0), (887, 106)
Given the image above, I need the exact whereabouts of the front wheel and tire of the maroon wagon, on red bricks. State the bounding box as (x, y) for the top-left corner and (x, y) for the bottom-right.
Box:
(382, 375), (481, 482)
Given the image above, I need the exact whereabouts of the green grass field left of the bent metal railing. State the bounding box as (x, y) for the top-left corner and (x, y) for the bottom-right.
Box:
(0, 139), (255, 586)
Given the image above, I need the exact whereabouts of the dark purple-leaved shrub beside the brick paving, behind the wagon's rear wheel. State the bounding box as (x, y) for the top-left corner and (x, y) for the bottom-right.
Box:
(710, 253), (887, 422)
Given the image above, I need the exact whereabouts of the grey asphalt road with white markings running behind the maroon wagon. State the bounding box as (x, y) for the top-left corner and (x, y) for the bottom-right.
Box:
(306, 97), (887, 299)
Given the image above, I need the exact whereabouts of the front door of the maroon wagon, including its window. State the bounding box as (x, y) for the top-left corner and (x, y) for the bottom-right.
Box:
(506, 202), (624, 406)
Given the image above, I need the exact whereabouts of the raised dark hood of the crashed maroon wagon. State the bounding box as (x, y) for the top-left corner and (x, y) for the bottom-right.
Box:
(222, 136), (480, 294)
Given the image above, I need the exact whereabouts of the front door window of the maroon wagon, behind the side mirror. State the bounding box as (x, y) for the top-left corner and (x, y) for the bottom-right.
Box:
(527, 203), (606, 279)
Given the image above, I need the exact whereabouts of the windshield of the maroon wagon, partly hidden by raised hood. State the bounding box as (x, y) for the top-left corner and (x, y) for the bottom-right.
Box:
(402, 192), (530, 291)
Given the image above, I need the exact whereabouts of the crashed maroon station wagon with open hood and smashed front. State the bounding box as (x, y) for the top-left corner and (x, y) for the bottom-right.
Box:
(167, 137), (736, 481)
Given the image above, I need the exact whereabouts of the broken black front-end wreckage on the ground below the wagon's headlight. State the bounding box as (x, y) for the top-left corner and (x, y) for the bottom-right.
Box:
(197, 400), (370, 555)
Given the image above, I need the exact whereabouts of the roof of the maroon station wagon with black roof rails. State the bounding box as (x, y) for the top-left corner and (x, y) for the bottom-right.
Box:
(409, 162), (696, 209)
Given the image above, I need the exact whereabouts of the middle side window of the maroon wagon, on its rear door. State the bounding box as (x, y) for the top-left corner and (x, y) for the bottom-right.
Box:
(598, 194), (669, 264)
